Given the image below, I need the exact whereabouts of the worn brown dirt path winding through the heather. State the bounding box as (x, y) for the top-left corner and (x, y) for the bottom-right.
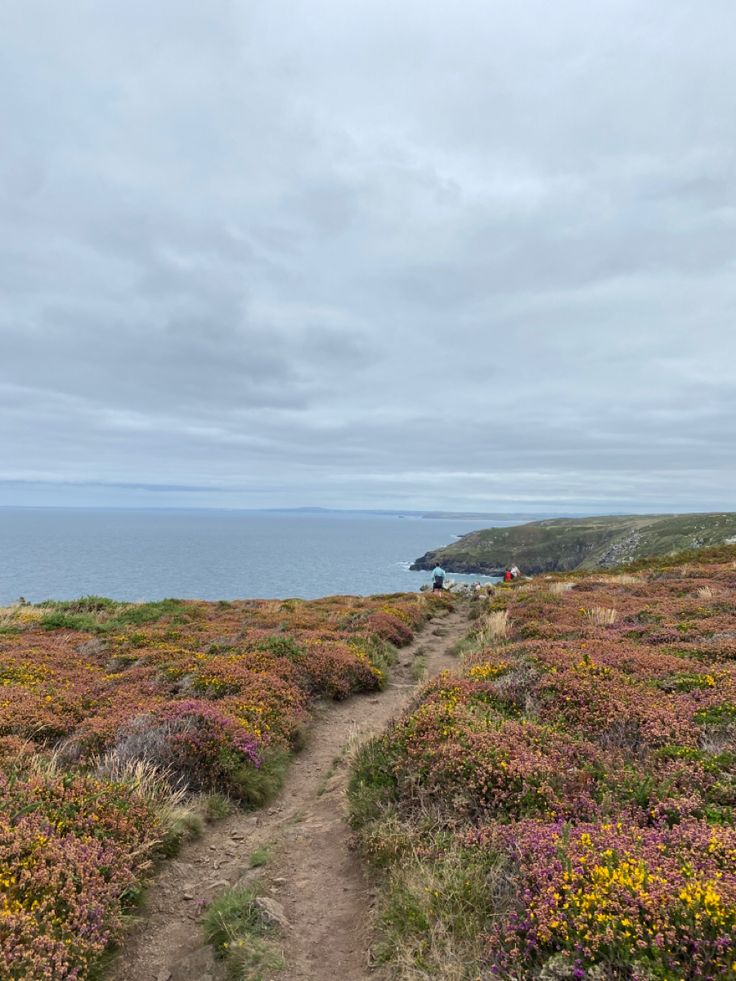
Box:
(111, 609), (467, 981)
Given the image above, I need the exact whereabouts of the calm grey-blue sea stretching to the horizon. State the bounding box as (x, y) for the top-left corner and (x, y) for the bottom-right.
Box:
(0, 508), (518, 604)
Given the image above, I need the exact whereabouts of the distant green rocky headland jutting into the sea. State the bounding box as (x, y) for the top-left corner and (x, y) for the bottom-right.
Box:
(411, 512), (736, 575)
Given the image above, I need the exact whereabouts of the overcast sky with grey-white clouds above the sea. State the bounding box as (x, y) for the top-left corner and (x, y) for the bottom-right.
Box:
(0, 0), (736, 512)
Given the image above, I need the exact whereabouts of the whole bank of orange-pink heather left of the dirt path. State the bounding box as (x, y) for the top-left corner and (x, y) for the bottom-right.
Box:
(0, 595), (436, 981)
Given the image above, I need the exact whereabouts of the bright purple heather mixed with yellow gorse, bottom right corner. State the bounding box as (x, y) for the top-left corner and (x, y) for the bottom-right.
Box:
(468, 821), (736, 979)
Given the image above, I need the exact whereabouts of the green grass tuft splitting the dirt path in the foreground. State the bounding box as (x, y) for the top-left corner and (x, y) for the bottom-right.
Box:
(204, 885), (284, 981)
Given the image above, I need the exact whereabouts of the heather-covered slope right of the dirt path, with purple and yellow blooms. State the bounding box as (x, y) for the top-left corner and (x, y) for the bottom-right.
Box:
(349, 545), (736, 981)
